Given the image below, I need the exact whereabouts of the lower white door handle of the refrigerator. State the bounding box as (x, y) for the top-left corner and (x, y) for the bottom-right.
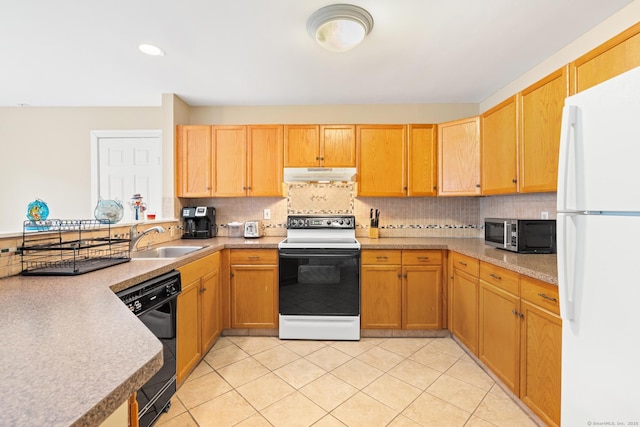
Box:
(557, 213), (578, 320)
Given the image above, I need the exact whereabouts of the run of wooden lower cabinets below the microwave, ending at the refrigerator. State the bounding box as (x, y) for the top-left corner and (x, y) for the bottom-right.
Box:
(449, 258), (562, 426)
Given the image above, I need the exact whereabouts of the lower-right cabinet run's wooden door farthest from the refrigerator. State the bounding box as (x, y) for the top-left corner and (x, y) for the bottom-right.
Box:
(451, 269), (478, 356)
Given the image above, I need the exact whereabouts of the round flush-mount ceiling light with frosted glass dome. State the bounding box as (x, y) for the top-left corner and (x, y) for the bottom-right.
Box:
(307, 4), (373, 52)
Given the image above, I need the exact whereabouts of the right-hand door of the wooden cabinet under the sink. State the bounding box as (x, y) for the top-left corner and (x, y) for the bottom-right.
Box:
(200, 268), (222, 354)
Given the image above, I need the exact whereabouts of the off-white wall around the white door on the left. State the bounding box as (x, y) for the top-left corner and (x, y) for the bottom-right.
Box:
(0, 107), (162, 233)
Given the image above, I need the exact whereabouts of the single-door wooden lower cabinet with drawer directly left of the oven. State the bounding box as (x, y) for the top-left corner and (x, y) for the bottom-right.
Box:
(229, 249), (278, 329)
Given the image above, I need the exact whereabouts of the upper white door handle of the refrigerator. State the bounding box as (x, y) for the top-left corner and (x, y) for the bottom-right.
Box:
(557, 105), (579, 212)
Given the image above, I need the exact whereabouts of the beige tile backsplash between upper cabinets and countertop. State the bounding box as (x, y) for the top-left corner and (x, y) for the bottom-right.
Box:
(188, 184), (556, 241)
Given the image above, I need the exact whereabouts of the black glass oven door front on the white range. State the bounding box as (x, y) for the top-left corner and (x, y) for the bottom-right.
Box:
(279, 252), (360, 316)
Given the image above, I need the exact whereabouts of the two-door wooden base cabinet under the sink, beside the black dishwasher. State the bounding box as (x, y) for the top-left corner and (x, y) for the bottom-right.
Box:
(176, 252), (222, 384)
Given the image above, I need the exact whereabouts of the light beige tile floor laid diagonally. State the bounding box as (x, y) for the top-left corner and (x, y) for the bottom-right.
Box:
(157, 337), (537, 427)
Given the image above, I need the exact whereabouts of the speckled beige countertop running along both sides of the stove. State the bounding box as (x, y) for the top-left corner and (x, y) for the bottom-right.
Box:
(0, 237), (557, 426)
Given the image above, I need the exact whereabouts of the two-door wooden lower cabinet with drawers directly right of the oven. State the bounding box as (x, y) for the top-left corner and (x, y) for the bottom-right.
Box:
(361, 250), (442, 329)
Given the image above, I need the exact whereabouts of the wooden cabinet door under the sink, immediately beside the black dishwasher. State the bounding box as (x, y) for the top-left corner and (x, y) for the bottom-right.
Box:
(176, 278), (202, 384)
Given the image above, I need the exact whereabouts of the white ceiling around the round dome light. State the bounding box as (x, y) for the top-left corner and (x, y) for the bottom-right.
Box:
(0, 0), (631, 106)
